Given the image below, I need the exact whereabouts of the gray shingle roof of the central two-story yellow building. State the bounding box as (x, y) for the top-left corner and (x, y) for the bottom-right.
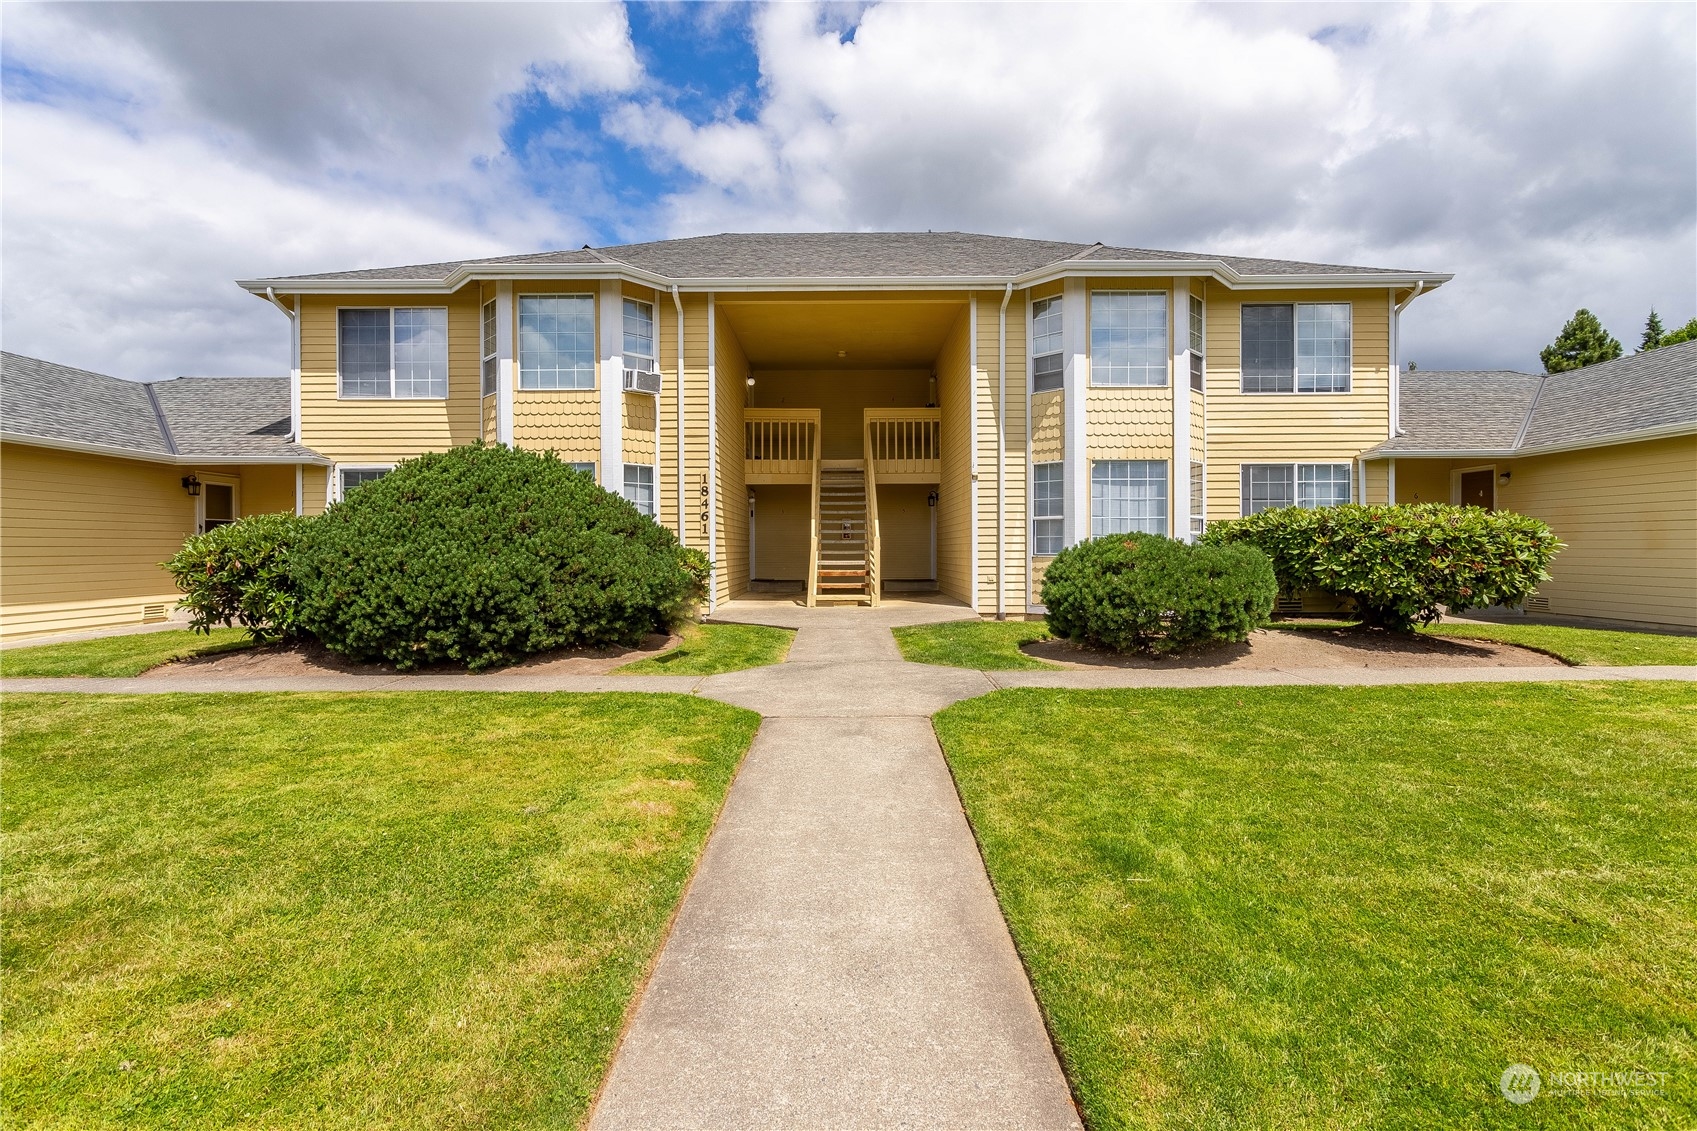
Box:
(257, 231), (1410, 282)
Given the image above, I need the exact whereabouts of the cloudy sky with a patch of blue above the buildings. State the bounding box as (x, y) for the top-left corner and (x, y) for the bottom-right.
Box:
(0, 3), (1697, 377)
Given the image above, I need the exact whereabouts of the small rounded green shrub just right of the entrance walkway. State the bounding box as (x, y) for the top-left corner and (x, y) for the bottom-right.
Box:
(1042, 533), (1278, 654)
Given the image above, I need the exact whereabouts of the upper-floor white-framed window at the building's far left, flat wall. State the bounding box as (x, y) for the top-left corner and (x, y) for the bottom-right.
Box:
(336, 306), (448, 399)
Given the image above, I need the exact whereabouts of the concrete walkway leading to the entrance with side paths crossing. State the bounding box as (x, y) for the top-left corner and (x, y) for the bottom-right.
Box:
(3, 601), (1697, 1129)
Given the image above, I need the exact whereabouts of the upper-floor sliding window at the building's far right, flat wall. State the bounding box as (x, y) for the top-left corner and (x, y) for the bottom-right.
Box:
(1242, 302), (1351, 392)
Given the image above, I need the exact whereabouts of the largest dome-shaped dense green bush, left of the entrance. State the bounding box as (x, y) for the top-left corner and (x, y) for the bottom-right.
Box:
(294, 443), (706, 671)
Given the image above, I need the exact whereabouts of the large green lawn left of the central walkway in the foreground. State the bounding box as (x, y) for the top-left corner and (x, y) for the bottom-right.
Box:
(0, 693), (759, 1128)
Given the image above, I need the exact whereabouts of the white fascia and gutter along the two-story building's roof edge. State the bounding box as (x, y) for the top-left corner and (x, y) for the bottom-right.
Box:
(236, 260), (1454, 297)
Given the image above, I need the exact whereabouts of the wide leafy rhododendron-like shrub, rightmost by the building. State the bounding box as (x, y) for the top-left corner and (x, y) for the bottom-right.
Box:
(1203, 503), (1561, 632)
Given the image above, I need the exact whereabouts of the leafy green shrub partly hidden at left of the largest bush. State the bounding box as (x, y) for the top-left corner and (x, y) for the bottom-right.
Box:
(165, 515), (307, 640)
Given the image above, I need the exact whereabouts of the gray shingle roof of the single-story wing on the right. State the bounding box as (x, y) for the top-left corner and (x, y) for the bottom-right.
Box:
(1371, 341), (1697, 455)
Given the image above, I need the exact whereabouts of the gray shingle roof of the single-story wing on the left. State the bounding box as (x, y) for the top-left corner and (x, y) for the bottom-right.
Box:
(0, 353), (326, 464)
